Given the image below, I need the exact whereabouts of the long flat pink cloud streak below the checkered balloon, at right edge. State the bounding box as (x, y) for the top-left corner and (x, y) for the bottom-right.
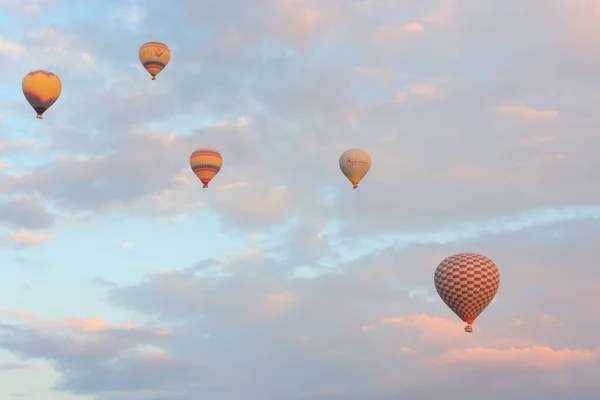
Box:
(430, 346), (600, 370)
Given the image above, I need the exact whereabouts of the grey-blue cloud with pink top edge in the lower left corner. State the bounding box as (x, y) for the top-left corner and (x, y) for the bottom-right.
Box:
(0, 318), (177, 396)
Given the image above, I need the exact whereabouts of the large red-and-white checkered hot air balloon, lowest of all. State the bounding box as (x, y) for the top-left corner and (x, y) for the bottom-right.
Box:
(433, 253), (500, 333)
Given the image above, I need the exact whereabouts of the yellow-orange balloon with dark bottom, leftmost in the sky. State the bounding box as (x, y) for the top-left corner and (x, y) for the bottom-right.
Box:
(21, 70), (62, 119)
